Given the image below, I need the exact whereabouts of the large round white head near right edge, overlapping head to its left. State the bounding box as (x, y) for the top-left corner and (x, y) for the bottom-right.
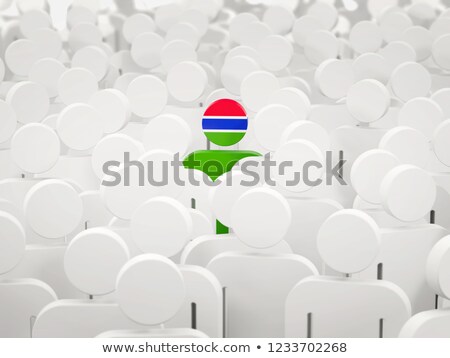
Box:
(380, 165), (436, 222)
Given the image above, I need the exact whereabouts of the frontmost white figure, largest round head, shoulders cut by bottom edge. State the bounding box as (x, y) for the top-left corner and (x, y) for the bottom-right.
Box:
(100, 254), (208, 338)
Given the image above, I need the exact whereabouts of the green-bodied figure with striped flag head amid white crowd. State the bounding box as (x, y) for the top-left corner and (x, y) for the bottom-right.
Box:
(183, 98), (261, 234)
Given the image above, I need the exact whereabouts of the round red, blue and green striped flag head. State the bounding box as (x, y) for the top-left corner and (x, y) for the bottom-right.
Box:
(202, 98), (248, 147)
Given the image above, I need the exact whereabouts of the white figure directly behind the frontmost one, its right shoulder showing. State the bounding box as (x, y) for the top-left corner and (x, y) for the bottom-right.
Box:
(130, 196), (223, 337)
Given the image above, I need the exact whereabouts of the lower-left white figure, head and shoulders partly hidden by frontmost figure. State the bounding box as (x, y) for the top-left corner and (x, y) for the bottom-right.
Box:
(33, 228), (136, 338)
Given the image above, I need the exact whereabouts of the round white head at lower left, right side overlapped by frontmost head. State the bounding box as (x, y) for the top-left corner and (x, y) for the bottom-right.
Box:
(64, 228), (130, 295)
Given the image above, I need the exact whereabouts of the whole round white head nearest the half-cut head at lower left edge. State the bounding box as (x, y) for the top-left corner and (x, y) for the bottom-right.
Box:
(24, 179), (83, 239)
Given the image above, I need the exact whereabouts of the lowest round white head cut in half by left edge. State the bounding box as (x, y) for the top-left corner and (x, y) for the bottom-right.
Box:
(0, 211), (25, 274)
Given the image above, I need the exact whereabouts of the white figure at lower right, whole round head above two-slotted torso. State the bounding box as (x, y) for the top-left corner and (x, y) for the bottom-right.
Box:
(285, 209), (411, 338)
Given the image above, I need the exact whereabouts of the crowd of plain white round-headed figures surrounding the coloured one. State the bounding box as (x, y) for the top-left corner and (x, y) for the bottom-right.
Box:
(0, 0), (450, 337)
